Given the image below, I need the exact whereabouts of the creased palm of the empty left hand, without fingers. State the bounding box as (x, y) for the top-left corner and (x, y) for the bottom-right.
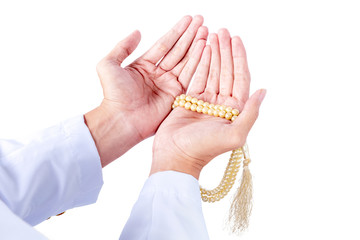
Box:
(100, 59), (183, 136)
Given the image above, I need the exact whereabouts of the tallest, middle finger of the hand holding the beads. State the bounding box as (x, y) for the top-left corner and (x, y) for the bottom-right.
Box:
(219, 29), (234, 96)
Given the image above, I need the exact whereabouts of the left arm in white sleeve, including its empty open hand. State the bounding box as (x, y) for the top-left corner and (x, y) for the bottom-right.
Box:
(0, 16), (207, 225)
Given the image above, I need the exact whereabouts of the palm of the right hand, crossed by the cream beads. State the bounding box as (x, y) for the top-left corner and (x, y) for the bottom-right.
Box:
(154, 93), (245, 164)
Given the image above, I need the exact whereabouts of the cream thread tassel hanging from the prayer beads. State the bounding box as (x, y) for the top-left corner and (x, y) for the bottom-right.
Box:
(229, 143), (252, 234)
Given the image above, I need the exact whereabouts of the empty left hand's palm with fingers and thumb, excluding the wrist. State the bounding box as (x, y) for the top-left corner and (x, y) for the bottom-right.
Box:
(98, 17), (207, 139)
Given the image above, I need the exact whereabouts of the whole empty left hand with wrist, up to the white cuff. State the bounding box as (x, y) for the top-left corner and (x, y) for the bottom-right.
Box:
(85, 16), (208, 166)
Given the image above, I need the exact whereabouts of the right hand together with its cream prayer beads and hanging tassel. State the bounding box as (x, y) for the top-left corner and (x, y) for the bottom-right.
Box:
(150, 29), (266, 232)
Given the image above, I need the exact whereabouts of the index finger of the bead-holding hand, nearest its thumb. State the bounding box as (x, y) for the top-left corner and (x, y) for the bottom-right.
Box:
(231, 37), (250, 103)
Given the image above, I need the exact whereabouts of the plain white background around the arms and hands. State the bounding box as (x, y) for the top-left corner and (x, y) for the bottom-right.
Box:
(0, 0), (360, 240)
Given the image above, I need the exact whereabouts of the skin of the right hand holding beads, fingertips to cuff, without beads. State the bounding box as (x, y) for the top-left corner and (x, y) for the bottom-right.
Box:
(150, 29), (266, 179)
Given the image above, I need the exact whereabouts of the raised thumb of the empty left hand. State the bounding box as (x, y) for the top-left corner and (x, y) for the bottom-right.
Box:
(107, 30), (141, 65)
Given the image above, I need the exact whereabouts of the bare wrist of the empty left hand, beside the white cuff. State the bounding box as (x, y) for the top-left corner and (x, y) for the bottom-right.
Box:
(84, 102), (142, 167)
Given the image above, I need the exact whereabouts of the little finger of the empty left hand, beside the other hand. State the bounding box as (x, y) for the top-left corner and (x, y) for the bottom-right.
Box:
(178, 40), (206, 92)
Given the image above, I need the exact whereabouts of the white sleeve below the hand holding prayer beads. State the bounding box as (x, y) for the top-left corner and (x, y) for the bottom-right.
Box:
(120, 171), (209, 240)
